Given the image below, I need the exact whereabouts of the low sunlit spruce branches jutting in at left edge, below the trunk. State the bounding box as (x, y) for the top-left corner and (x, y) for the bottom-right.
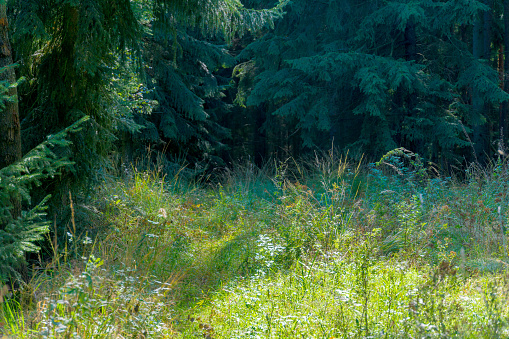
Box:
(0, 117), (88, 282)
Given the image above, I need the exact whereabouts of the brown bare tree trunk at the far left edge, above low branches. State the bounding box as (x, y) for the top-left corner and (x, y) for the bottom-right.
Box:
(0, 0), (21, 168)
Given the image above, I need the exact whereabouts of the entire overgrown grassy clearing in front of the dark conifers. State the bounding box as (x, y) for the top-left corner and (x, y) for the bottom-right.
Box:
(0, 156), (509, 338)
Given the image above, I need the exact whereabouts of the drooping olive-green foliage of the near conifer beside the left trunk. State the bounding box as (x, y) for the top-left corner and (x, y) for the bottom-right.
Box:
(9, 0), (139, 198)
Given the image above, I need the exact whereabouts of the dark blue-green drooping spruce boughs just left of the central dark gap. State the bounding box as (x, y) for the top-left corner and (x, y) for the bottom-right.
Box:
(141, 28), (233, 163)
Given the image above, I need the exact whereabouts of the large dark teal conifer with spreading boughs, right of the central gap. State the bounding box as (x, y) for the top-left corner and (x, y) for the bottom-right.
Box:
(238, 0), (509, 166)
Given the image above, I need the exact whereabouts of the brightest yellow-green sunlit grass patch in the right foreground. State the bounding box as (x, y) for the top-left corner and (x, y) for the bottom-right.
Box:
(191, 247), (509, 338)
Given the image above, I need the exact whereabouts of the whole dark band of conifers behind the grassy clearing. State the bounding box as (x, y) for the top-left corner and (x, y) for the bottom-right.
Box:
(8, 0), (509, 177)
